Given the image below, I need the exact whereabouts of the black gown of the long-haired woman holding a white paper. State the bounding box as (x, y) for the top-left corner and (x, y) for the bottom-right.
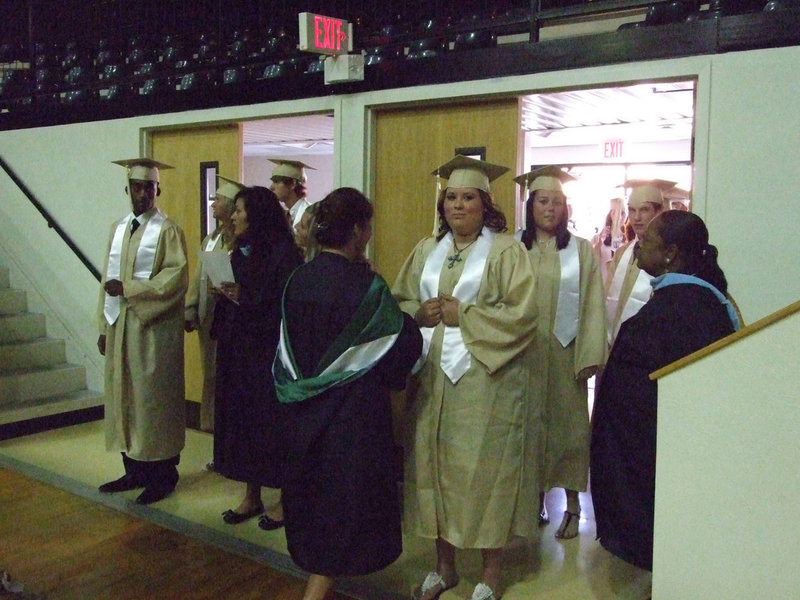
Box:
(212, 241), (302, 488)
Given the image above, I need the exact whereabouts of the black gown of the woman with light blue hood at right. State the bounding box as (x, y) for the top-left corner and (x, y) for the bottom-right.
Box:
(590, 284), (733, 569)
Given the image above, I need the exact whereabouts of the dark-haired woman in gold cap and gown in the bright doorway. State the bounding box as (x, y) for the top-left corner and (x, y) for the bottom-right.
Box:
(515, 166), (606, 539)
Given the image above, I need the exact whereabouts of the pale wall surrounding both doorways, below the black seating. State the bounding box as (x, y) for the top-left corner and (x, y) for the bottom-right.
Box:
(0, 47), (800, 392)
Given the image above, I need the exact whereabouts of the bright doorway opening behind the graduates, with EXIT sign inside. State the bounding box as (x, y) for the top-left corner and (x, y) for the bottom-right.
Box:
(516, 79), (696, 240)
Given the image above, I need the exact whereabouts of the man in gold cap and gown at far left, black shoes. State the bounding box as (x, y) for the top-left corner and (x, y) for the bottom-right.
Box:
(98, 159), (188, 504)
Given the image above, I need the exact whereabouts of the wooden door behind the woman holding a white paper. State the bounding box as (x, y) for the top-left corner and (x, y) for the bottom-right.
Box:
(151, 123), (242, 402)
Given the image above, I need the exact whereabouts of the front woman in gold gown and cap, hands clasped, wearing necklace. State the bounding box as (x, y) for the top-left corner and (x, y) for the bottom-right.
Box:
(392, 156), (540, 600)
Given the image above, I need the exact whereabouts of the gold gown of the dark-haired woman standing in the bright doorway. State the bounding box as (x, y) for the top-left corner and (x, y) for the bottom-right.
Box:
(528, 236), (607, 491)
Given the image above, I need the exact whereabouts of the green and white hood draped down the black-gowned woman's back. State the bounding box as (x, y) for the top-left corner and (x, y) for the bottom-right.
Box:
(272, 275), (403, 403)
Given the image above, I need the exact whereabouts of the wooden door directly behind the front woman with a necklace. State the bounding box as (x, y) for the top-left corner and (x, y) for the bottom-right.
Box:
(372, 98), (522, 285)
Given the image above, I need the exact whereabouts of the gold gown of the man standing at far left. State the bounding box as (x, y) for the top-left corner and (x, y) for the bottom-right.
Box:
(97, 209), (188, 461)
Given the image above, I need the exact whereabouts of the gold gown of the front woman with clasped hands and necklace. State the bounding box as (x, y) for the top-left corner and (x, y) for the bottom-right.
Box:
(392, 234), (540, 548)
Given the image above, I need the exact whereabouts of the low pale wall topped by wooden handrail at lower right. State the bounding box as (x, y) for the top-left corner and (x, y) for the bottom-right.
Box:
(653, 313), (800, 600)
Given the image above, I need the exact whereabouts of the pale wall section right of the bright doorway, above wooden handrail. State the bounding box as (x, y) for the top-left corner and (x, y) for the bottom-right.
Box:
(697, 47), (800, 323)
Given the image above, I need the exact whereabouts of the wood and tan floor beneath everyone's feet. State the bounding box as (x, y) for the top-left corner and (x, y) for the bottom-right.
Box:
(0, 421), (652, 600)
